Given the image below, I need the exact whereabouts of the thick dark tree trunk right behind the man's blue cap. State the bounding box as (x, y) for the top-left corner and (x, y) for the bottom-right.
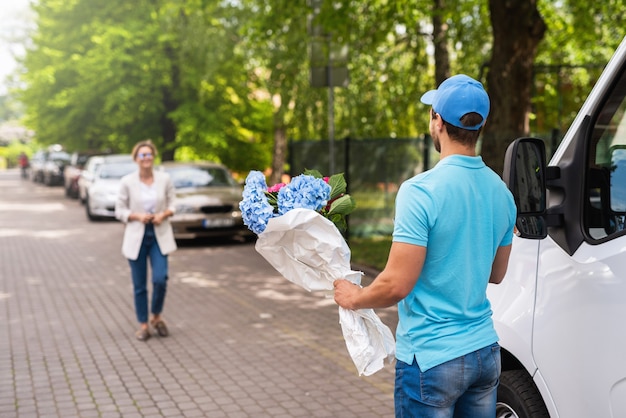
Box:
(481, 0), (546, 174)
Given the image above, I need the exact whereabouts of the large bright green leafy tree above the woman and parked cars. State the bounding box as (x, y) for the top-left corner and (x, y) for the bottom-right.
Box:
(22, 0), (268, 168)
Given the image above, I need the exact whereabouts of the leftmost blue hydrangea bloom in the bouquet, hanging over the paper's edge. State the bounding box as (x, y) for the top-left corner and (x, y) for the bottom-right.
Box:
(239, 171), (274, 235)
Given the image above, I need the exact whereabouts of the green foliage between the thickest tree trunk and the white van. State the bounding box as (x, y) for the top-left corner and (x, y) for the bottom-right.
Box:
(531, 0), (626, 136)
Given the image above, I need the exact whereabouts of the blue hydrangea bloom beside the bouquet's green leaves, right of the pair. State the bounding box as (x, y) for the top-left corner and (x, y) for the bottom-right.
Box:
(278, 174), (331, 215)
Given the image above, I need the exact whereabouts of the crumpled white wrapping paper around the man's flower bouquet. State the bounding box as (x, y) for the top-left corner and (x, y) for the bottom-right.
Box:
(255, 209), (395, 376)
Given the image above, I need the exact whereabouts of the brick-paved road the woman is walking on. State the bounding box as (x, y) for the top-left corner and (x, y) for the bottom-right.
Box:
(0, 171), (397, 418)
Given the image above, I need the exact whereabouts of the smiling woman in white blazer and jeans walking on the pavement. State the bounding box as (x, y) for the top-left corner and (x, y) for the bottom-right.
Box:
(115, 140), (176, 341)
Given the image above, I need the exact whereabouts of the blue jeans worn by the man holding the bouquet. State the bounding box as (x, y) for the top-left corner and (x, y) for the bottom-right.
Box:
(394, 343), (501, 418)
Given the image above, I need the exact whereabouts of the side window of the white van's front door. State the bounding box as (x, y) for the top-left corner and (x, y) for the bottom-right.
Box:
(584, 68), (626, 240)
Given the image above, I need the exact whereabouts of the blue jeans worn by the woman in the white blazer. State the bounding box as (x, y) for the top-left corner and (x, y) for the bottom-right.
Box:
(128, 224), (167, 324)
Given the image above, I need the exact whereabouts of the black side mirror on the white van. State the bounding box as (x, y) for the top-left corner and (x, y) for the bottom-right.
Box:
(502, 138), (548, 239)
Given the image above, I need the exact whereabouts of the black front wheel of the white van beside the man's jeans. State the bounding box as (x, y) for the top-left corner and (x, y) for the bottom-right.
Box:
(496, 370), (550, 418)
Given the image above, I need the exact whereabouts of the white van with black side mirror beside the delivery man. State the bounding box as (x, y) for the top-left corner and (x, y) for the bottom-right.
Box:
(488, 38), (626, 418)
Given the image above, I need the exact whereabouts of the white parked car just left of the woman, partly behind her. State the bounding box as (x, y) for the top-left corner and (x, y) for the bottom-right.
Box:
(85, 159), (137, 221)
